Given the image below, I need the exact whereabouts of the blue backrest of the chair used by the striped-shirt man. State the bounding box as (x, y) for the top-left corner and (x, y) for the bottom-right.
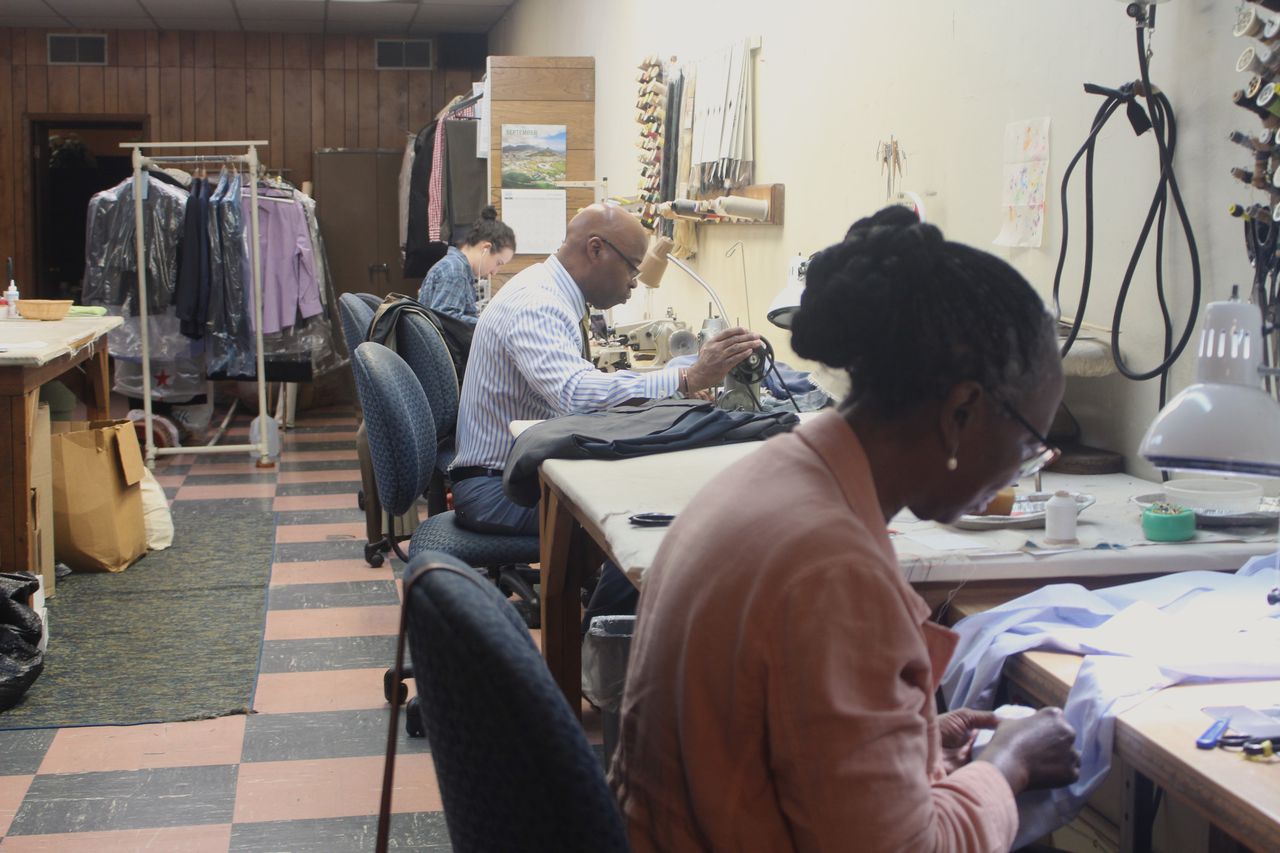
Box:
(351, 341), (435, 515)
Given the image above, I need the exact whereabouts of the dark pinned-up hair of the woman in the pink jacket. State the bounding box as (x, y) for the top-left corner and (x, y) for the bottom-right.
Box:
(791, 206), (1055, 415)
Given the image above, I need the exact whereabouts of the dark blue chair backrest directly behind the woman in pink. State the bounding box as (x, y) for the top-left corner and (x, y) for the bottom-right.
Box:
(404, 551), (628, 853)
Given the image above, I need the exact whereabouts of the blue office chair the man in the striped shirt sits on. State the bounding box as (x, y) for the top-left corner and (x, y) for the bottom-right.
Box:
(351, 342), (541, 712)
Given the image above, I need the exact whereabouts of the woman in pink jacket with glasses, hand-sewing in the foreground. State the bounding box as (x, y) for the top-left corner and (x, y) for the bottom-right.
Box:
(611, 207), (1079, 850)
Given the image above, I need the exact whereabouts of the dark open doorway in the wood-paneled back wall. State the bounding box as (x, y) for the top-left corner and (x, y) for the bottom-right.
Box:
(31, 115), (147, 301)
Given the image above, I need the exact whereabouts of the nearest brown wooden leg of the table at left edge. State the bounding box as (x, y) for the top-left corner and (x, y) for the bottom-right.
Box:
(0, 389), (40, 571)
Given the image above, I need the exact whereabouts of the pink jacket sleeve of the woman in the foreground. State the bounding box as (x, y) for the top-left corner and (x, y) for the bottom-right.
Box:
(767, 551), (1018, 852)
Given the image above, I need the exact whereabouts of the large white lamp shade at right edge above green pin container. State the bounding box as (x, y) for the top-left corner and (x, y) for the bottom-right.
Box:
(1138, 383), (1280, 476)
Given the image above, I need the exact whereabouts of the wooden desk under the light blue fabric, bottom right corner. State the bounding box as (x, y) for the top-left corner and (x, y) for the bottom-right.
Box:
(955, 599), (1280, 850)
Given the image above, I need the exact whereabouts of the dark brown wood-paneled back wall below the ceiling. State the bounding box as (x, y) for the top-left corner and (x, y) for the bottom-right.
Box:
(0, 28), (484, 280)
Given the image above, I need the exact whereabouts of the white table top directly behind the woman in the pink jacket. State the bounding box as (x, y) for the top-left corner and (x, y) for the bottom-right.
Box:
(541, 442), (1276, 585)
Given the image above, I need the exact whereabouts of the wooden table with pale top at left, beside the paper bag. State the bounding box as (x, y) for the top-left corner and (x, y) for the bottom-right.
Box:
(0, 316), (123, 573)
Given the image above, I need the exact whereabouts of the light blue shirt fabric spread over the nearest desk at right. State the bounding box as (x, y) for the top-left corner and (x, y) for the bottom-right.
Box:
(940, 555), (1280, 849)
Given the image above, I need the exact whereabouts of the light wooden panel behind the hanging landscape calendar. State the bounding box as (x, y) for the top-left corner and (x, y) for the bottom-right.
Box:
(489, 56), (596, 289)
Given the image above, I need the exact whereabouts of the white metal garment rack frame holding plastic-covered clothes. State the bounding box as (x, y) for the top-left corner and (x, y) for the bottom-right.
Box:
(120, 140), (275, 467)
